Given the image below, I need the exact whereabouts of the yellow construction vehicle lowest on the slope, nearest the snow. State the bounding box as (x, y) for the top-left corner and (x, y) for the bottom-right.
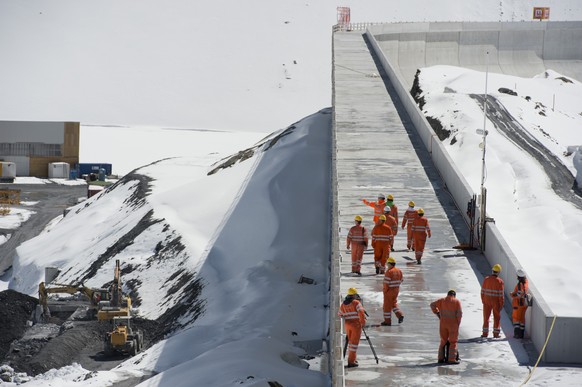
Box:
(103, 316), (143, 356)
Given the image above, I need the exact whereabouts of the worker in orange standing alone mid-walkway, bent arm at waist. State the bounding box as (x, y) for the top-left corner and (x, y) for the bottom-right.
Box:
(430, 289), (463, 364)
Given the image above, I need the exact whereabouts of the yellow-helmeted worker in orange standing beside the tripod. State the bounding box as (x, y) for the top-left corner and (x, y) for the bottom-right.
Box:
(338, 288), (366, 367)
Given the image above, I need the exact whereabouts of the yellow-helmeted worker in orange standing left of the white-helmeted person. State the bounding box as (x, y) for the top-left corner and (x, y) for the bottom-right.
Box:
(481, 264), (504, 337)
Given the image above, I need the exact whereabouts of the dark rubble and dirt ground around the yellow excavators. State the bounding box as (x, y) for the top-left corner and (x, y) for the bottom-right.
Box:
(0, 290), (165, 384)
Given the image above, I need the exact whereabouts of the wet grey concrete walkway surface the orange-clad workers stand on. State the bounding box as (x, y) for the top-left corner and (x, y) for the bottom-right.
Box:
(334, 32), (531, 386)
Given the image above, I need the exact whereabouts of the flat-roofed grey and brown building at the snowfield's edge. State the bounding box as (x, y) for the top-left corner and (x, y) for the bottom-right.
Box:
(0, 121), (80, 177)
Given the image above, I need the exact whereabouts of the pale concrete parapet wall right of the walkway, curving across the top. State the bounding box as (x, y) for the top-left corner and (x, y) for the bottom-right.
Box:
(366, 22), (582, 364)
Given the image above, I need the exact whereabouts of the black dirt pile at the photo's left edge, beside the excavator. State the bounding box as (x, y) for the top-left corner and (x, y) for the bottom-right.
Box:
(0, 290), (38, 359)
